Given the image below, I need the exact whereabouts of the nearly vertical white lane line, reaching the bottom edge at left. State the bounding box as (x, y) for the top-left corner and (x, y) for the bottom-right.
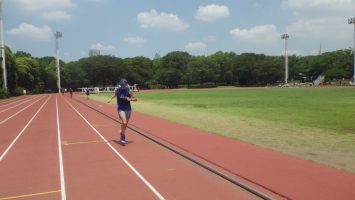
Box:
(55, 95), (67, 200)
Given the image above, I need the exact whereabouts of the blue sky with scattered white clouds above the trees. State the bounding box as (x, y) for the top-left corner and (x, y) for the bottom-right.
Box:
(3, 0), (355, 61)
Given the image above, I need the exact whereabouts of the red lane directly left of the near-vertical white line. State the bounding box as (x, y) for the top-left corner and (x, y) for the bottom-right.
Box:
(0, 97), (60, 199)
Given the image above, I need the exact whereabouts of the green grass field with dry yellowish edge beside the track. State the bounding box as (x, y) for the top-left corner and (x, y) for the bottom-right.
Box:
(89, 88), (355, 173)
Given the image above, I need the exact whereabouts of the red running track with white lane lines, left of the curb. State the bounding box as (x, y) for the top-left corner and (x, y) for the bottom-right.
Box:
(0, 95), (257, 200)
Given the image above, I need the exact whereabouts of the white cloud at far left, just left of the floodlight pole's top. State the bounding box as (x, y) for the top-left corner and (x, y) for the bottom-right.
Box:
(7, 23), (53, 40)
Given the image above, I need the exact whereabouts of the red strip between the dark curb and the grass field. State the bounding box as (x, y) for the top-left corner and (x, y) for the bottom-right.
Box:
(80, 94), (355, 200)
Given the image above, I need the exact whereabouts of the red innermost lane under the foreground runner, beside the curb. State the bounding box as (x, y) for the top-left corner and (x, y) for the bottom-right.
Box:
(66, 97), (259, 199)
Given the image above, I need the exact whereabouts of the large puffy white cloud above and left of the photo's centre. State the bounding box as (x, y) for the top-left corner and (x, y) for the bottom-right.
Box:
(137, 9), (189, 31)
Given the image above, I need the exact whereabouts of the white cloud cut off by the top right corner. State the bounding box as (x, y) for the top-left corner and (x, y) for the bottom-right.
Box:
(285, 0), (355, 12)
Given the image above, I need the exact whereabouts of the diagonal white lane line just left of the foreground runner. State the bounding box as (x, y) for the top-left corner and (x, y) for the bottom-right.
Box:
(65, 99), (165, 200)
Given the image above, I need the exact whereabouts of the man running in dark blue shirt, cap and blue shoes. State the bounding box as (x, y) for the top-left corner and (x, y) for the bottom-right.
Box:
(108, 79), (137, 145)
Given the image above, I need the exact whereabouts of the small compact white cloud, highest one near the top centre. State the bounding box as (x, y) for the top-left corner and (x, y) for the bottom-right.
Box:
(195, 4), (229, 22)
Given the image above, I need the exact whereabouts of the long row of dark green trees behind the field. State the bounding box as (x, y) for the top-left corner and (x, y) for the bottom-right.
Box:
(0, 47), (354, 97)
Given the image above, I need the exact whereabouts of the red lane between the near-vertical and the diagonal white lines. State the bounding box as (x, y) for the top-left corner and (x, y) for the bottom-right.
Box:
(58, 96), (161, 199)
